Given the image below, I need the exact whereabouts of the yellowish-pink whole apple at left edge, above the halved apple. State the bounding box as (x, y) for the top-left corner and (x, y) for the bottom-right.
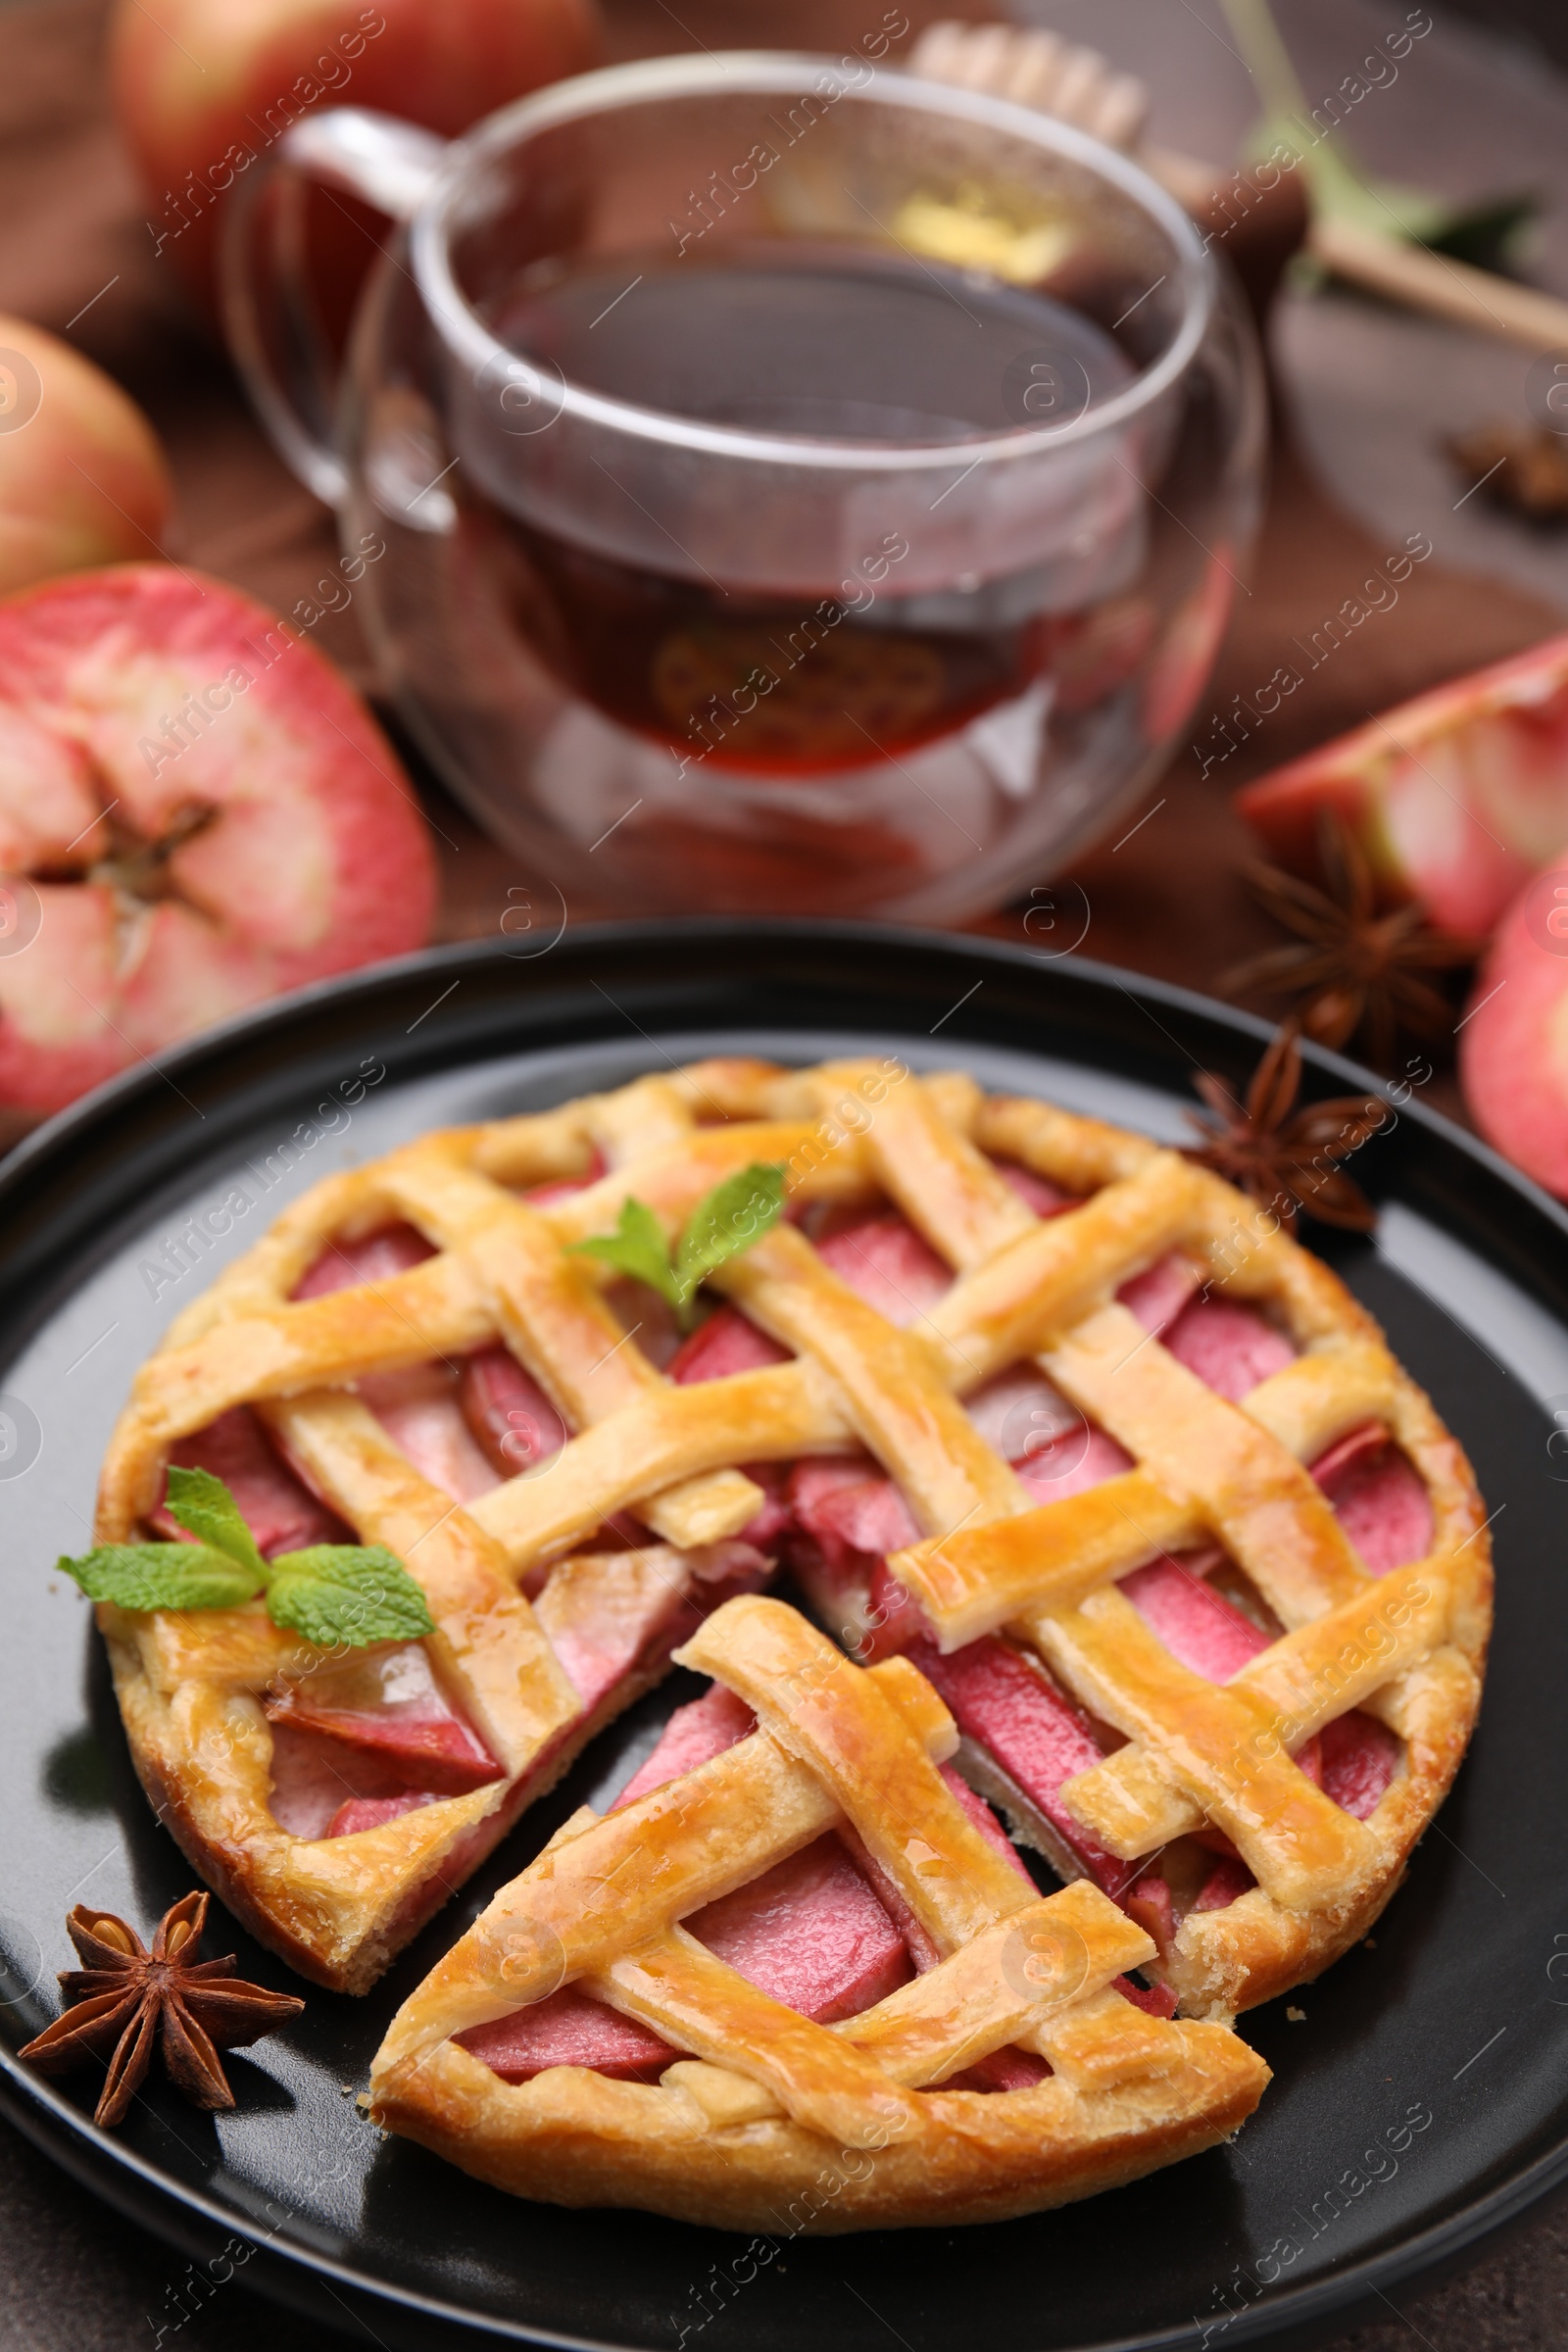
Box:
(0, 313), (170, 595)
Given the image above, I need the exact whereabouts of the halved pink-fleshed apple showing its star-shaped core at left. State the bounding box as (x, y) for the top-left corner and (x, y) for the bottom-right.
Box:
(0, 564), (435, 1110)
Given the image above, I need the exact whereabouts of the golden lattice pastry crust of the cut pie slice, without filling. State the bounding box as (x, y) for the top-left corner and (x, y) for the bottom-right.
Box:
(371, 1599), (1267, 2221)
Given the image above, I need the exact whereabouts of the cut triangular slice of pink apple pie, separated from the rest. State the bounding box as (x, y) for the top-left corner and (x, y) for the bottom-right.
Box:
(371, 1597), (1267, 2236)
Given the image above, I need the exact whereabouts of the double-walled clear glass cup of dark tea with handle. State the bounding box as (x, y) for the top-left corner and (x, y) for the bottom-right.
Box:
(225, 35), (1262, 922)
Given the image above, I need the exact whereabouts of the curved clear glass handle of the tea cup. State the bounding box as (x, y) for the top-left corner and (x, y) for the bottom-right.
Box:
(223, 106), (447, 506)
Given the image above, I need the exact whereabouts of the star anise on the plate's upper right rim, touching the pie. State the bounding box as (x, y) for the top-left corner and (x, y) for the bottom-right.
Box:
(1185, 1021), (1390, 1233)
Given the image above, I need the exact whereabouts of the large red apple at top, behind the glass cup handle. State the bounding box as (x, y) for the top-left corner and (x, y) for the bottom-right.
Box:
(111, 0), (602, 304)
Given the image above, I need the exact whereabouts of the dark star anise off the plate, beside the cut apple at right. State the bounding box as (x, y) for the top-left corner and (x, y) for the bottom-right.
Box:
(1220, 811), (1479, 1065)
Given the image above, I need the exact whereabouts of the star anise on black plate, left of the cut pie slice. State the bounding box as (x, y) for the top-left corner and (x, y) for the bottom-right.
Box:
(19, 1891), (306, 2124)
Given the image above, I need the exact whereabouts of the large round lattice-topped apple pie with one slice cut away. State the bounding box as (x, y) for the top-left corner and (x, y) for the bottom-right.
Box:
(99, 1060), (1491, 2016)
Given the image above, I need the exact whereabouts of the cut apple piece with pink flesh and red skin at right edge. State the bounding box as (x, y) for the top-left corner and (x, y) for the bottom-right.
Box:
(1237, 635), (1568, 939)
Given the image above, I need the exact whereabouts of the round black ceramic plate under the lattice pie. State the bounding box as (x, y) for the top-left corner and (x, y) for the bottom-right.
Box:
(0, 922), (1568, 2352)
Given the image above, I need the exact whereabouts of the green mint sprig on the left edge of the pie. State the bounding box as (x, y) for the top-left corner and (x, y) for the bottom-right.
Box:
(59, 1465), (435, 1648)
